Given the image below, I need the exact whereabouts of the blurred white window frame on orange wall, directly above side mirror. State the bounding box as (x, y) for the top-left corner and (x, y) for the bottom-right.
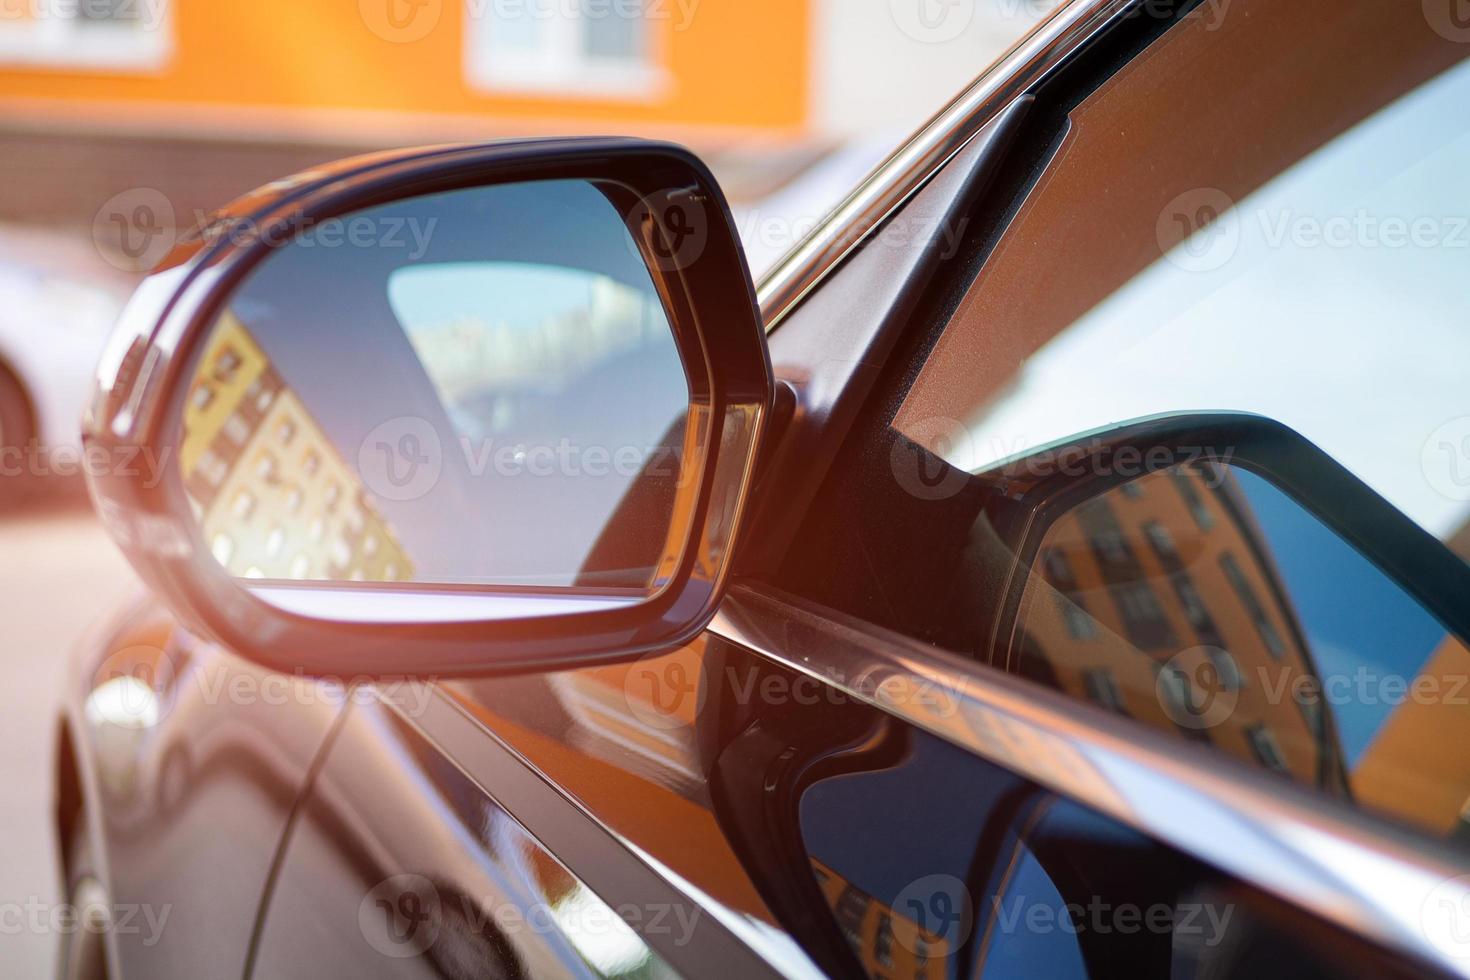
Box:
(465, 0), (669, 101)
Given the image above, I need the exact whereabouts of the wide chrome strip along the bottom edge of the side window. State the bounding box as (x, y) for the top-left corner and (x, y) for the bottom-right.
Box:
(710, 585), (1470, 976)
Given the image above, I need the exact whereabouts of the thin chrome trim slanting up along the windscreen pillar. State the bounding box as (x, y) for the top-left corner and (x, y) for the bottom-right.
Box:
(756, 0), (1141, 334)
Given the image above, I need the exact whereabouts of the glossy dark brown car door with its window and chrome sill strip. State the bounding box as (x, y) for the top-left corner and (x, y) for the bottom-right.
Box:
(246, 0), (1470, 977)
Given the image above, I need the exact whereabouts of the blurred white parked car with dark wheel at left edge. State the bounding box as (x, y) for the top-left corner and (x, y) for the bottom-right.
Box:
(0, 263), (122, 476)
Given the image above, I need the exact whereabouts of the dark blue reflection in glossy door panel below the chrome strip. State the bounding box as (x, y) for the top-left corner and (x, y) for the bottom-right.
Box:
(799, 726), (1417, 980)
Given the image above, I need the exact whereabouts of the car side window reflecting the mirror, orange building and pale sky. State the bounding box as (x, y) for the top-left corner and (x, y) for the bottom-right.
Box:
(779, 0), (1470, 837)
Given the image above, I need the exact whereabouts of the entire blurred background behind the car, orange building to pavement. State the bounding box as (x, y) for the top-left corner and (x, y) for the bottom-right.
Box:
(0, 0), (1055, 976)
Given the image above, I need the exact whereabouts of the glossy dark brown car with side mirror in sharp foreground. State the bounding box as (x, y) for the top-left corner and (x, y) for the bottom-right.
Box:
(54, 0), (1470, 979)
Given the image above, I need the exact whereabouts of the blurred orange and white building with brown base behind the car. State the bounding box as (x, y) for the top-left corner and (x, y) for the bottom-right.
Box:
(0, 0), (1033, 252)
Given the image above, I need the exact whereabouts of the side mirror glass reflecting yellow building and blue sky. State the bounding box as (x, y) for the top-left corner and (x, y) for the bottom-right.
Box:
(179, 181), (700, 597)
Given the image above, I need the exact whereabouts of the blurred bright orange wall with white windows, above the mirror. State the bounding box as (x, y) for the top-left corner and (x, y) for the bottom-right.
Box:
(0, 0), (809, 141)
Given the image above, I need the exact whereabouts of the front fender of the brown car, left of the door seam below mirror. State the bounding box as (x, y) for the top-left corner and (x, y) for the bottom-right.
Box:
(70, 602), (345, 976)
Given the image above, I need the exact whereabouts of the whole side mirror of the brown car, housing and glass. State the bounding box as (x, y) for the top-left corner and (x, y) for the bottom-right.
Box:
(84, 140), (773, 676)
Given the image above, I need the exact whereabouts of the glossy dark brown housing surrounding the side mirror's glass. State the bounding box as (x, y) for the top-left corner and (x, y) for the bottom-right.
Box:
(82, 140), (775, 677)
